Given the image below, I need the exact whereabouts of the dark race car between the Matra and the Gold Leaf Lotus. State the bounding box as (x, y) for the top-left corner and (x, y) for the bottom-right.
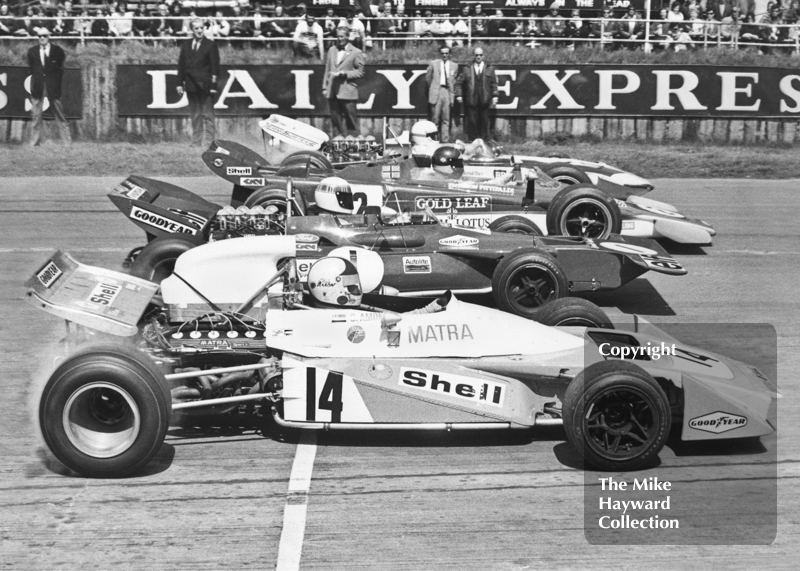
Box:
(109, 176), (686, 318)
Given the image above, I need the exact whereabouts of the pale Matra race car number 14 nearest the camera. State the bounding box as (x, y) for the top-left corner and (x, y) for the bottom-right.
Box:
(26, 236), (776, 477)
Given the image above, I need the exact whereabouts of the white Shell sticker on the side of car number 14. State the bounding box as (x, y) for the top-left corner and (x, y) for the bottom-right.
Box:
(399, 367), (507, 408)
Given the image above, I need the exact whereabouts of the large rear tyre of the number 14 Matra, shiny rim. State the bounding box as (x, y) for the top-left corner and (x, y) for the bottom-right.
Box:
(39, 344), (172, 478)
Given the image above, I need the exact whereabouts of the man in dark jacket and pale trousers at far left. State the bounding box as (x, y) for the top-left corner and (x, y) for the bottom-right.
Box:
(28, 27), (72, 147)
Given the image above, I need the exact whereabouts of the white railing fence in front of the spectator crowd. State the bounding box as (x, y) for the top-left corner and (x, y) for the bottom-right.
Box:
(0, 16), (800, 54)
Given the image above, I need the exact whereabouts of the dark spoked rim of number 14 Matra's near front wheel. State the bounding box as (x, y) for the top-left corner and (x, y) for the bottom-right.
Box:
(583, 387), (658, 460)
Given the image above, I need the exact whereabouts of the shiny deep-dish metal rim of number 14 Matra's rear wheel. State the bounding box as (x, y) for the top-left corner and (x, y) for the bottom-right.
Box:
(62, 382), (141, 458)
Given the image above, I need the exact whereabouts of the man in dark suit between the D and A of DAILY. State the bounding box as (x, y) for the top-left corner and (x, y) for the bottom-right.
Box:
(178, 19), (219, 146)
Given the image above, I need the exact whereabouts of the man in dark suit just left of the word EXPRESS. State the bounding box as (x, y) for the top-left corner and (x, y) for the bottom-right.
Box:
(456, 48), (497, 141)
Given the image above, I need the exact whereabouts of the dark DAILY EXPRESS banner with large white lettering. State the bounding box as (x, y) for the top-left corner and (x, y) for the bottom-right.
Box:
(117, 65), (800, 118)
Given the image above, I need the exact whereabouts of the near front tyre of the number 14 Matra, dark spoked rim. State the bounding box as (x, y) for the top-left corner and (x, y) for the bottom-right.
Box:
(562, 360), (672, 471)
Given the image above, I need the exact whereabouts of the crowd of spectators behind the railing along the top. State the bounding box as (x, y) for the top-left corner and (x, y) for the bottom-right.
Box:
(0, 0), (800, 54)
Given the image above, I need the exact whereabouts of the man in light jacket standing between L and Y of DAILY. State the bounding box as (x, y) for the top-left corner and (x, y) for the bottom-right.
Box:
(322, 28), (364, 137)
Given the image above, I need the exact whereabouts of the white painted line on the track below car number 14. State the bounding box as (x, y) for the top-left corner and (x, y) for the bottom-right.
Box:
(275, 430), (317, 571)
